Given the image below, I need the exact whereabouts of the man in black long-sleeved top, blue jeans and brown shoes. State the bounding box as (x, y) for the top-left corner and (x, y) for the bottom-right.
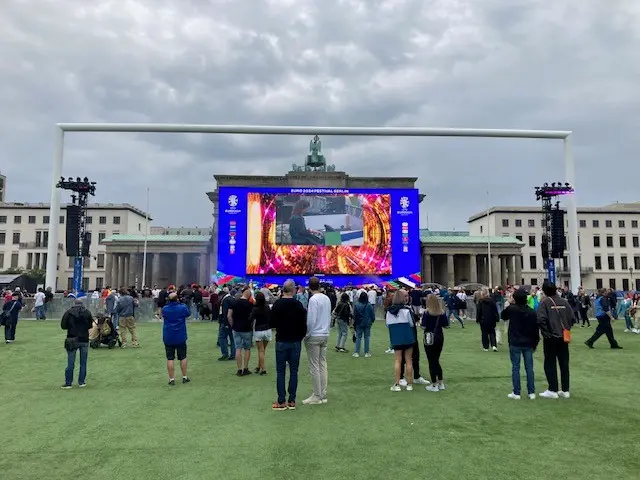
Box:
(271, 280), (307, 410)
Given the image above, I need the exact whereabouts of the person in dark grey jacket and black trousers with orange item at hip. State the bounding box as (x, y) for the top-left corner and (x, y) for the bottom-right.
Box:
(537, 281), (573, 399)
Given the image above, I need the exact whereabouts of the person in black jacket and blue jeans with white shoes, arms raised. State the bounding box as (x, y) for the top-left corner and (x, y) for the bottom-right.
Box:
(501, 288), (540, 400)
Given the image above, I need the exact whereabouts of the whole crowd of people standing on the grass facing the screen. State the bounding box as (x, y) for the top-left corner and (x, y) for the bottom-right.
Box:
(0, 277), (640, 410)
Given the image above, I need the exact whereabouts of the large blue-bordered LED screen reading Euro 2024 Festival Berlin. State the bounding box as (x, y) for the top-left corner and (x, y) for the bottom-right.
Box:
(218, 187), (420, 284)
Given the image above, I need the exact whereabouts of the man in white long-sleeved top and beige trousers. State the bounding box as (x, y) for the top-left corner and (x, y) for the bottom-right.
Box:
(302, 277), (331, 405)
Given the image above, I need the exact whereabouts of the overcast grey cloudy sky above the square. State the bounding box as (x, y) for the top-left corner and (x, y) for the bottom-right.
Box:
(0, 0), (640, 229)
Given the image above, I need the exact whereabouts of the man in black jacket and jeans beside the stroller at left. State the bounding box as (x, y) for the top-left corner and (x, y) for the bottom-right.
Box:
(60, 299), (93, 390)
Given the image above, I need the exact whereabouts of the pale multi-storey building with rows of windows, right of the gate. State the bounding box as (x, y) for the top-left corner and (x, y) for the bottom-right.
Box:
(469, 202), (640, 291)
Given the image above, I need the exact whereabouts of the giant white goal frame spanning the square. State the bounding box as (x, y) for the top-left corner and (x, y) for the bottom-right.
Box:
(45, 123), (580, 292)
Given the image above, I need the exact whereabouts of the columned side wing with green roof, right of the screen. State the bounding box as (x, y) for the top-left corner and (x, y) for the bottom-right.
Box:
(420, 230), (524, 287)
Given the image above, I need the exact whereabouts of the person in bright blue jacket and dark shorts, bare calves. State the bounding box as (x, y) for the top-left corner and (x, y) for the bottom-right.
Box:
(162, 293), (191, 386)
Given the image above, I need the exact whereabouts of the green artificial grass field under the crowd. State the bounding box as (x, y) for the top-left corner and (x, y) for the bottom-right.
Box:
(0, 321), (640, 480)
